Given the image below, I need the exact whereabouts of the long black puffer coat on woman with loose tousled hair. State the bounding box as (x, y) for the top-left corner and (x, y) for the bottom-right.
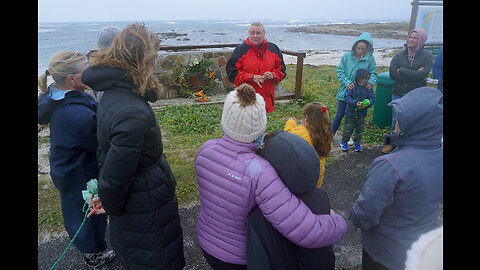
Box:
(82, 67), (185, 270)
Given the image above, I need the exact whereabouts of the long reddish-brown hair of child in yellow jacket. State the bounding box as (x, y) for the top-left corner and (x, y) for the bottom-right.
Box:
(303, 102), (333, 157)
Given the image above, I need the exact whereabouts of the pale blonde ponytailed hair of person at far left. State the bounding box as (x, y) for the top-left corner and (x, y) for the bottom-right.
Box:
(38, 51), (86, 94)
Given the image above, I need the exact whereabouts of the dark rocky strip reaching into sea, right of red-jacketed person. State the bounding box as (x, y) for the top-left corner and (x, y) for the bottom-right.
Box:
(286, 22), (408, 40)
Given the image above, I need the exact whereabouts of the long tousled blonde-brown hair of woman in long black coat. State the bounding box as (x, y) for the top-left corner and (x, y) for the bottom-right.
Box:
(90, 23), (163, 96)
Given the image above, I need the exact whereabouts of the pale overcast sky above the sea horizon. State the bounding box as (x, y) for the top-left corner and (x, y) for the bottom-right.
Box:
(38, 0), (412, 22)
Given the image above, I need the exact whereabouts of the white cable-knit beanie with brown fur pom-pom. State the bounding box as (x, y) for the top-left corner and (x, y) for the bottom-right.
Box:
(221, 83), (267, 143)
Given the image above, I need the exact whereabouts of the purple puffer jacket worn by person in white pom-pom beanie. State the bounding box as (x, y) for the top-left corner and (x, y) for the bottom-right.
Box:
(195, 135), (347, 265)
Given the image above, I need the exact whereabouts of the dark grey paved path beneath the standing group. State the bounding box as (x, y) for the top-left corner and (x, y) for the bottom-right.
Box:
(38, 144), (390, 269)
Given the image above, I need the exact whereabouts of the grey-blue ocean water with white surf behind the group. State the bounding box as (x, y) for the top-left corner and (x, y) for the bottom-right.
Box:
(38, 20), (405, 74)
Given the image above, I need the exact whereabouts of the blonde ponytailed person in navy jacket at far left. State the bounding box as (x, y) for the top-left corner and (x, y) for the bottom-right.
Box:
(38, 51), (115, 269)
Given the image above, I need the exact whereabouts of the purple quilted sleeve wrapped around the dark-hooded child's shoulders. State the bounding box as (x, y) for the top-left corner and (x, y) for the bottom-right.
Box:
(255, 162), (347, 248)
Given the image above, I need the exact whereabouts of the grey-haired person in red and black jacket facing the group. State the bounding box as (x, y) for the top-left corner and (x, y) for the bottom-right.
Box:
(226, 22), (286, 148)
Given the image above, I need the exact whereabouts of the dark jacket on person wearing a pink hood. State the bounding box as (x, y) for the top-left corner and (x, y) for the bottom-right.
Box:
(389, 47), (433, 96)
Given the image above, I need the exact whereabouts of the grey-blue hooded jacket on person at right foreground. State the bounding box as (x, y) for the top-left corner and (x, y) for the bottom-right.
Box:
(350, 87), (443, 270)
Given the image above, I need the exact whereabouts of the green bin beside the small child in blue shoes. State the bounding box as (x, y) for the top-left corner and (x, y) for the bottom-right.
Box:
(372, 71), (395, 129)
